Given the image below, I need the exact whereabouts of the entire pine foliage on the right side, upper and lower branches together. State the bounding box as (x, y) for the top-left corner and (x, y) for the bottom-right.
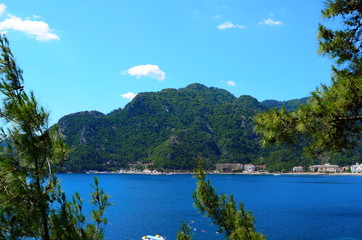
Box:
(255, 0), (362, 153)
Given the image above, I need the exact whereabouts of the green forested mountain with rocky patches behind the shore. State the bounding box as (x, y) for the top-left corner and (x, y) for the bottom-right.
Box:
(58, 84), (358, 171)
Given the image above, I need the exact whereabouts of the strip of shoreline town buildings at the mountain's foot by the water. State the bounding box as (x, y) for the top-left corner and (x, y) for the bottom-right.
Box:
(80, 163), (362, 175)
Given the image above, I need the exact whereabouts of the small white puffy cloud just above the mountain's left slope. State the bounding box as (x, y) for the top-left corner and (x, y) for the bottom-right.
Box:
(124, 64), (166, 81)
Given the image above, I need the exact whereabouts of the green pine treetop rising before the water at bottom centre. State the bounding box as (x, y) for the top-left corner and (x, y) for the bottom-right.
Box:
(193, 163), (265, 240)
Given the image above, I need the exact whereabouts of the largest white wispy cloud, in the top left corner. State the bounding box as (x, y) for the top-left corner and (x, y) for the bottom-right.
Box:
(0, 4), (60, 41)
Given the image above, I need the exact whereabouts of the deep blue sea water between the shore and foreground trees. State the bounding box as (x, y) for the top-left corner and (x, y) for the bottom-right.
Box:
(59, 174), (362, 240)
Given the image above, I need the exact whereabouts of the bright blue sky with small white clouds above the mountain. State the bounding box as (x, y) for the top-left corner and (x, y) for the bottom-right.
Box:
(0, 0), (332, 123)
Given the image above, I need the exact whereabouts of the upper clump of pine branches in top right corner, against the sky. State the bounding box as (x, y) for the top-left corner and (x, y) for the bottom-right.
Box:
(318, 0), (362, 77)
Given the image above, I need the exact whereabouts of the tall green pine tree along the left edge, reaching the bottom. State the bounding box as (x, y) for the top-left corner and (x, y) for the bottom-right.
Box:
(0, 36), (109, 240)
